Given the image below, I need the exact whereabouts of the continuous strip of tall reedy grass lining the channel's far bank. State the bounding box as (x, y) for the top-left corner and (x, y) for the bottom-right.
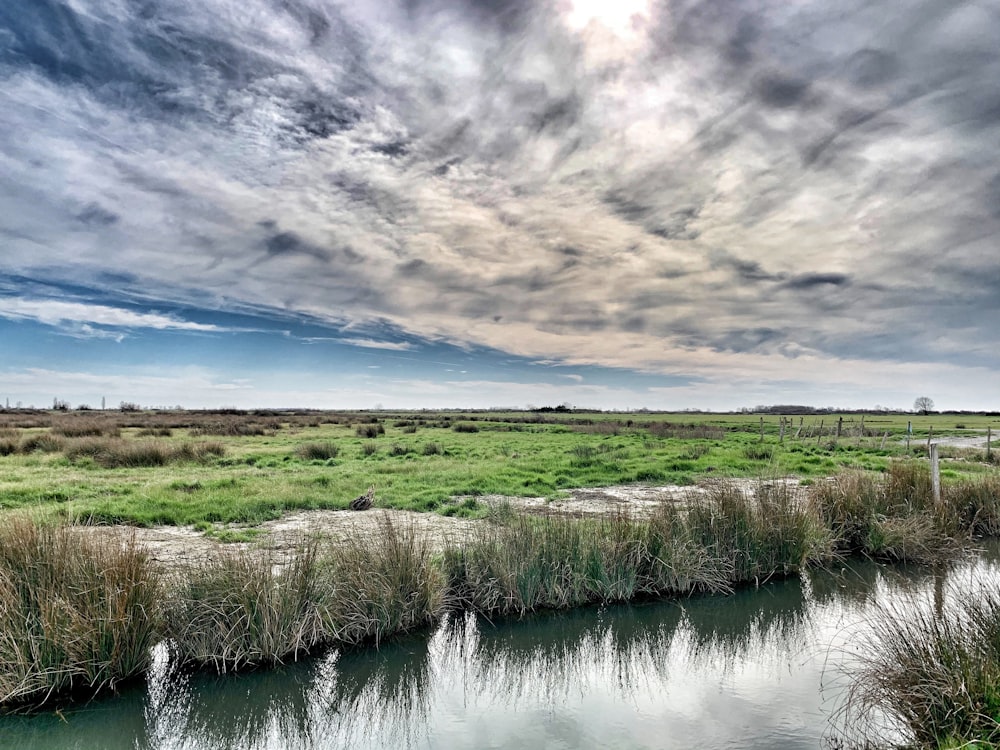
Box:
(0, 463), (1000, 748)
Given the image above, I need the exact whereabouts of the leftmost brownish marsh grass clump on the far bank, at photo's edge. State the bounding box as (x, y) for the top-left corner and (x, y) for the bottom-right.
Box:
(0, 516), (160, 706)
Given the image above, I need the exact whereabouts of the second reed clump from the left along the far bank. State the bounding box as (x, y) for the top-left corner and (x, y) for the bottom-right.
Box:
(163, 517), (447, 672)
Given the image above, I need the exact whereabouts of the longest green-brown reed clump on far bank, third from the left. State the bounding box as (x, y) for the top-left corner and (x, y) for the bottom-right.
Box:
(444, 485), (830, 614)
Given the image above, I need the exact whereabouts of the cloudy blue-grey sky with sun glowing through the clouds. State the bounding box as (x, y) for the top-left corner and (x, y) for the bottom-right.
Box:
(0, 0), (1000, 410)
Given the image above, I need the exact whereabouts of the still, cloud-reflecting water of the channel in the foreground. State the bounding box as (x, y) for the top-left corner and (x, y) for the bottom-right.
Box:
(0, 550), (1000, 750)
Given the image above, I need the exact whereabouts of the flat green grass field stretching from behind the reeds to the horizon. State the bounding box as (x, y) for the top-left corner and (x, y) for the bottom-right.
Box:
(0, 411), (1000, 527)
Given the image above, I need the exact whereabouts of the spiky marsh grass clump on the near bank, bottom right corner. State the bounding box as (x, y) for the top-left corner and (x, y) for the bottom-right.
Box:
(840, 586), (1000, 749)
